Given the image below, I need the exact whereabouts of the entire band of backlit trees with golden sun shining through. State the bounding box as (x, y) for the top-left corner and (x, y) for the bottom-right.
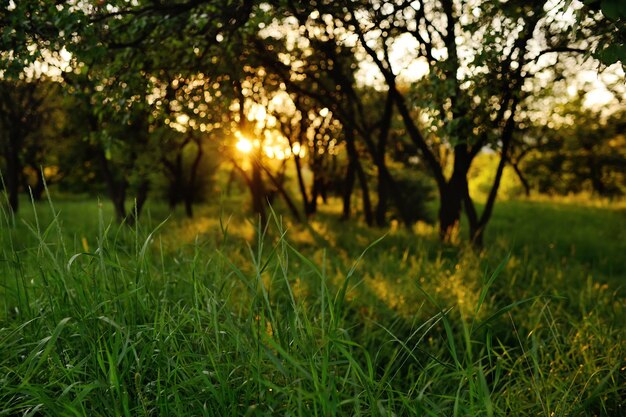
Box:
(0, 0), (626, 245)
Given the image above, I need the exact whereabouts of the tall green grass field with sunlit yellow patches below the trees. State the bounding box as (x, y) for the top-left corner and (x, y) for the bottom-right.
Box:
(0, 199), (626, 417)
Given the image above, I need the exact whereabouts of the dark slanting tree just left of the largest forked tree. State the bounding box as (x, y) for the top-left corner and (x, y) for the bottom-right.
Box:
(249, 10), (414, 225)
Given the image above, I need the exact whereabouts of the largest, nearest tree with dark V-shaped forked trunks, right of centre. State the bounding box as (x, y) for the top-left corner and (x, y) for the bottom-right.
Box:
(268, 0), (604, 246)
